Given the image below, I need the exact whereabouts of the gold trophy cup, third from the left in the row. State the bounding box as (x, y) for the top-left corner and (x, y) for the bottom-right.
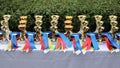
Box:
(34, 15), (43, 41)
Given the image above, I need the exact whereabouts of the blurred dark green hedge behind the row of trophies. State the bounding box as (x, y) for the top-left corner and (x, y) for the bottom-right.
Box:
(0, 0), (120, 32)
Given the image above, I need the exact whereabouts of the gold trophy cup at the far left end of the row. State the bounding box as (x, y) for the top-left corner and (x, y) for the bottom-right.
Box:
(1, 14), (11, 41)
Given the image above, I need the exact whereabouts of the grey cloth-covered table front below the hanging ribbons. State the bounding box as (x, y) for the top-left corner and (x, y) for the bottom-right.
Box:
(0, 50), (120, 68)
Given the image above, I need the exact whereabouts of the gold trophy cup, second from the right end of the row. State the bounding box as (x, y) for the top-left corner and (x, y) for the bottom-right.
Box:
(94, 15), (104, 42)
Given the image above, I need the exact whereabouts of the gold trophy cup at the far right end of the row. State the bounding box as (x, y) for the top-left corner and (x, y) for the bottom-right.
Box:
(109, 15), (119, 39)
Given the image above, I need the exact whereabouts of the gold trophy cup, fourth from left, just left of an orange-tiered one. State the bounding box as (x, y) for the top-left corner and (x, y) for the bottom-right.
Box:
(50, 15), (59, 42)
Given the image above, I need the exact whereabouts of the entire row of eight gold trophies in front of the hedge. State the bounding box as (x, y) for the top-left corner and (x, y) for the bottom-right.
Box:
(1, 15), (119, 41)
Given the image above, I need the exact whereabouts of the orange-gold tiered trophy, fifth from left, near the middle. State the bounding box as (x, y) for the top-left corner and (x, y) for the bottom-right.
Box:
(64, 16), (73, 40)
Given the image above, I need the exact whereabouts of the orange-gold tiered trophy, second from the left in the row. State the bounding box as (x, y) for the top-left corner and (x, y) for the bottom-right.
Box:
(18, 16), (27, 41)
